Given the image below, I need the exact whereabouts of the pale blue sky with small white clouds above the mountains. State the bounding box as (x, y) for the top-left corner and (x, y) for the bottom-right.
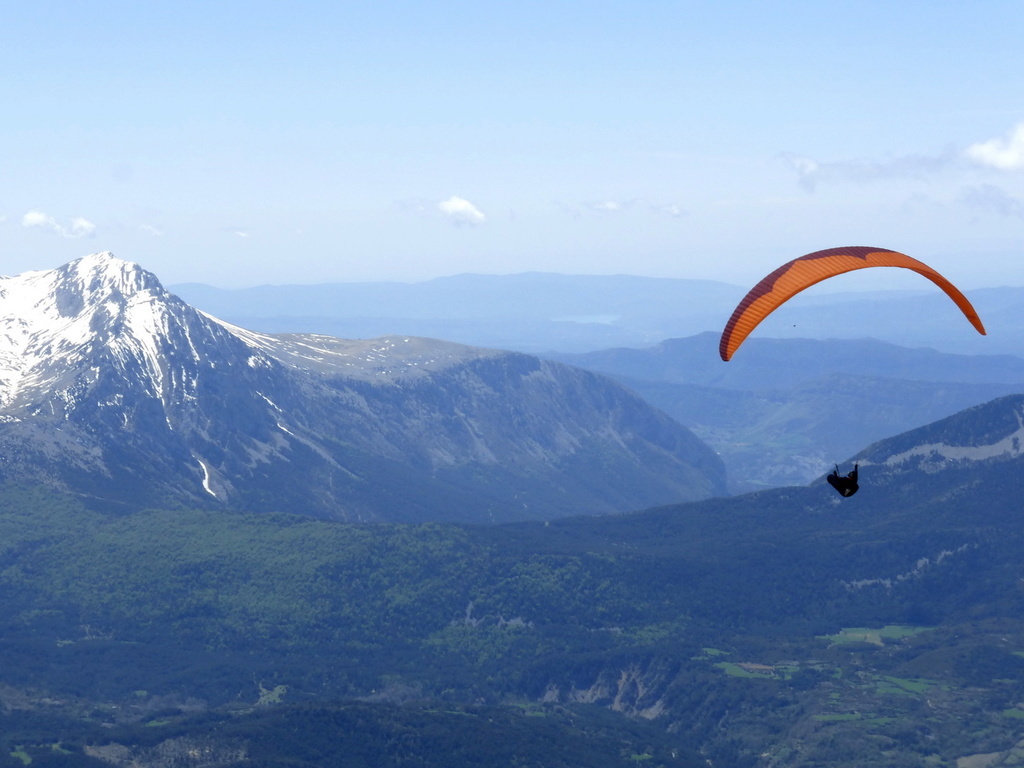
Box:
(0, 0), (1024, 288)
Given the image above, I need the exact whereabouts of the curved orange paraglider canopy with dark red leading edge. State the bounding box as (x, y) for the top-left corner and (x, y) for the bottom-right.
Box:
(718, 246), (985, 360)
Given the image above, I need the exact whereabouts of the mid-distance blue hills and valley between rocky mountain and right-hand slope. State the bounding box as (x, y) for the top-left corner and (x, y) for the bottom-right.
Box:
(552, 333), (1024, 492)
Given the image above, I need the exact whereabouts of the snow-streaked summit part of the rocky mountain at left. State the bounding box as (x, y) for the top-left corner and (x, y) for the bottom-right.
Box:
(0, 252), (268, 418)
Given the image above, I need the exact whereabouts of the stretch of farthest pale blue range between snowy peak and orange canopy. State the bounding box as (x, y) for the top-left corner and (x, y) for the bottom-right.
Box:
(172, 272), (743, 352)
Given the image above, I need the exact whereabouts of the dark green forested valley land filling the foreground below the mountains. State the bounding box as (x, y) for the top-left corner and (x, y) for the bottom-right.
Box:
(0, 448), (1024, 768)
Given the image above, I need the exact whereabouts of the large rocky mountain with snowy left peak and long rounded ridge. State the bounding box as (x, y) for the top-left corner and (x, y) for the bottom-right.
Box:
(0, 253), (724, 521)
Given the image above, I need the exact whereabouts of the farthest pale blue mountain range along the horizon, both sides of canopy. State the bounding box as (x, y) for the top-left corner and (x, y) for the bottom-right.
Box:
(172, 272), (1024, 354)
